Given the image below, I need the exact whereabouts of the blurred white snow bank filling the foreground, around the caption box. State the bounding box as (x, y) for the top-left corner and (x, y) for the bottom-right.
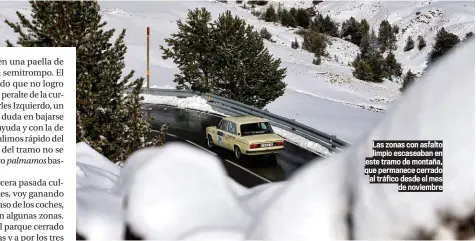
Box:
(77, 40), (475, 240)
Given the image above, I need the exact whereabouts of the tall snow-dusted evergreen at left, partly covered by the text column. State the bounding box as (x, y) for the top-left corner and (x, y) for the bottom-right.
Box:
(5, 1), (165, 162)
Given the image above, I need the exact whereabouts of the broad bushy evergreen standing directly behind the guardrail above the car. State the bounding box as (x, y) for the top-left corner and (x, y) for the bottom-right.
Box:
(161, 8), (286, 108)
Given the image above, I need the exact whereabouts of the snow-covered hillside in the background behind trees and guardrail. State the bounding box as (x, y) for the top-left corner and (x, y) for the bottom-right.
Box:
(0, 0), (474, 143)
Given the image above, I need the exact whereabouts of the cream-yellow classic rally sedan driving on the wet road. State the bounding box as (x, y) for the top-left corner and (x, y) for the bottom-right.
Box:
(206, 116), (284, 159)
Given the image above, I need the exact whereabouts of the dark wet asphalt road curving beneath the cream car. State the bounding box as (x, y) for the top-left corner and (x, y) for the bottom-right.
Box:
(144, 104), (322, 187)
